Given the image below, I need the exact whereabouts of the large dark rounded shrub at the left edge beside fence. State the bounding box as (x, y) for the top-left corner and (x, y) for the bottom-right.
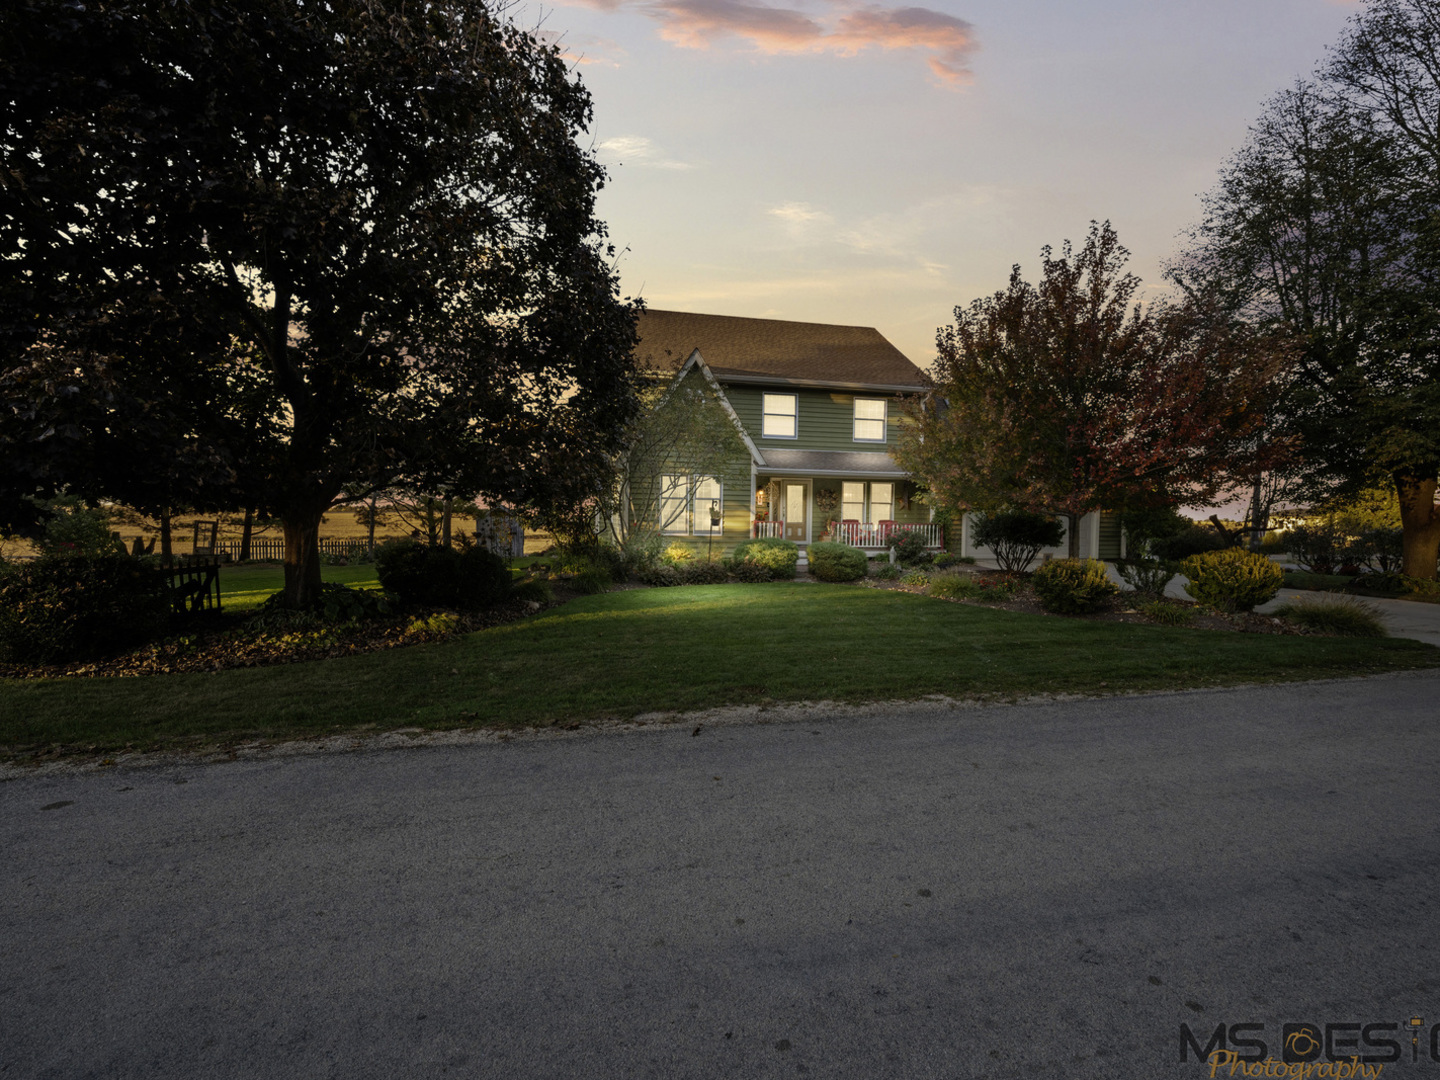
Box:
(0, 554), (170, 664)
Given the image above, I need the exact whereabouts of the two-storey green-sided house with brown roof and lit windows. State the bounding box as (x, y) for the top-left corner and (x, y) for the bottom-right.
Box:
(635, 311), (1123, 559)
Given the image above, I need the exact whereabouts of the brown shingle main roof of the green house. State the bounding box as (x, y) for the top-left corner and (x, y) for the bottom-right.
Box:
(635, 311), (924, 387)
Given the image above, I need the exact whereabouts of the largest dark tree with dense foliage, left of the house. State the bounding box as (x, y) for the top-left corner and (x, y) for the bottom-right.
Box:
(0, 0), (635, 605)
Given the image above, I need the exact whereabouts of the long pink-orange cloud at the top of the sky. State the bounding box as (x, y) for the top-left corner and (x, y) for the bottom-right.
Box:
(572, 0), (976, 86)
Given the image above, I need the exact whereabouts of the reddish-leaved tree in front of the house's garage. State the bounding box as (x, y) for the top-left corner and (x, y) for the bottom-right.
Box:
(899, 222), (1287, 552)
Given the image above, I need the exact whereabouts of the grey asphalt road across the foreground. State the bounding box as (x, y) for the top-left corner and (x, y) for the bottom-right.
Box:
(0, 674), (1440, 1080)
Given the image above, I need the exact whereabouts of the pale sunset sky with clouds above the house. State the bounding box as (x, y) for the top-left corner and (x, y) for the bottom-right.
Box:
(532, 0), (1355, 367)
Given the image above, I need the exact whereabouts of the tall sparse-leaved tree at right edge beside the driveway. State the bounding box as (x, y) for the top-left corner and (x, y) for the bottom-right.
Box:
(1174, 0), (1440, 577)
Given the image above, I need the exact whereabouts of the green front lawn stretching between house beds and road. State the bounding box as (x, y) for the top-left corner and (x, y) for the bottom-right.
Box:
(0, 583), (1440, 749)
